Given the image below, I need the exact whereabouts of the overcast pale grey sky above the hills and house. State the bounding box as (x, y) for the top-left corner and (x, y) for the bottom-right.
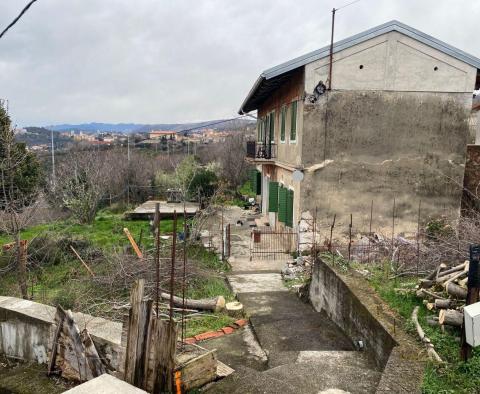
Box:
(0, 0), (480, 126)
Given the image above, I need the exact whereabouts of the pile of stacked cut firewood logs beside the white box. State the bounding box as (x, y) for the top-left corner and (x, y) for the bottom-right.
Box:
(416, 261), (469, 327)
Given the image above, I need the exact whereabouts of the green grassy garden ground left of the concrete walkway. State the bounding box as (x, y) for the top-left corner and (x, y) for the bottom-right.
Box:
(0, 210), (233, 336)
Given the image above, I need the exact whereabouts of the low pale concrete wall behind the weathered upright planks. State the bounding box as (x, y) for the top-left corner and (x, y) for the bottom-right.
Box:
(0, 296), (123, 370)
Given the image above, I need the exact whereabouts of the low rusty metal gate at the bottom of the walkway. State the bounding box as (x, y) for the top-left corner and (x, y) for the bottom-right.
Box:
(250, 227), (298, 261)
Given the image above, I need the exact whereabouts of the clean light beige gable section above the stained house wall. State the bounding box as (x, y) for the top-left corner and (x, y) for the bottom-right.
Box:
(305, 32), (477, 93)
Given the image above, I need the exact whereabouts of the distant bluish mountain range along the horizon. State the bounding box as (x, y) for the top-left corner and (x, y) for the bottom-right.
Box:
(45, 118), (255, 133)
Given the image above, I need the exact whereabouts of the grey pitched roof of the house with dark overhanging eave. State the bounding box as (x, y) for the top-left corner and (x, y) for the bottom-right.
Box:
(239, 20), (480, 114)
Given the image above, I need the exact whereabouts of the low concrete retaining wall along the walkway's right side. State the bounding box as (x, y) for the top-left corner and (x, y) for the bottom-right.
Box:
(310, 260), (425, 393)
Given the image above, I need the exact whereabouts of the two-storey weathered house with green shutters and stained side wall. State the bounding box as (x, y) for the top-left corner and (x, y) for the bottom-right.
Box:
(239, 21), (480, 231)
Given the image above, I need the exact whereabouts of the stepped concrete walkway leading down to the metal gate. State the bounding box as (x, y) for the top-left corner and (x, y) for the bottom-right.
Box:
(207, 212), (381, 394)
